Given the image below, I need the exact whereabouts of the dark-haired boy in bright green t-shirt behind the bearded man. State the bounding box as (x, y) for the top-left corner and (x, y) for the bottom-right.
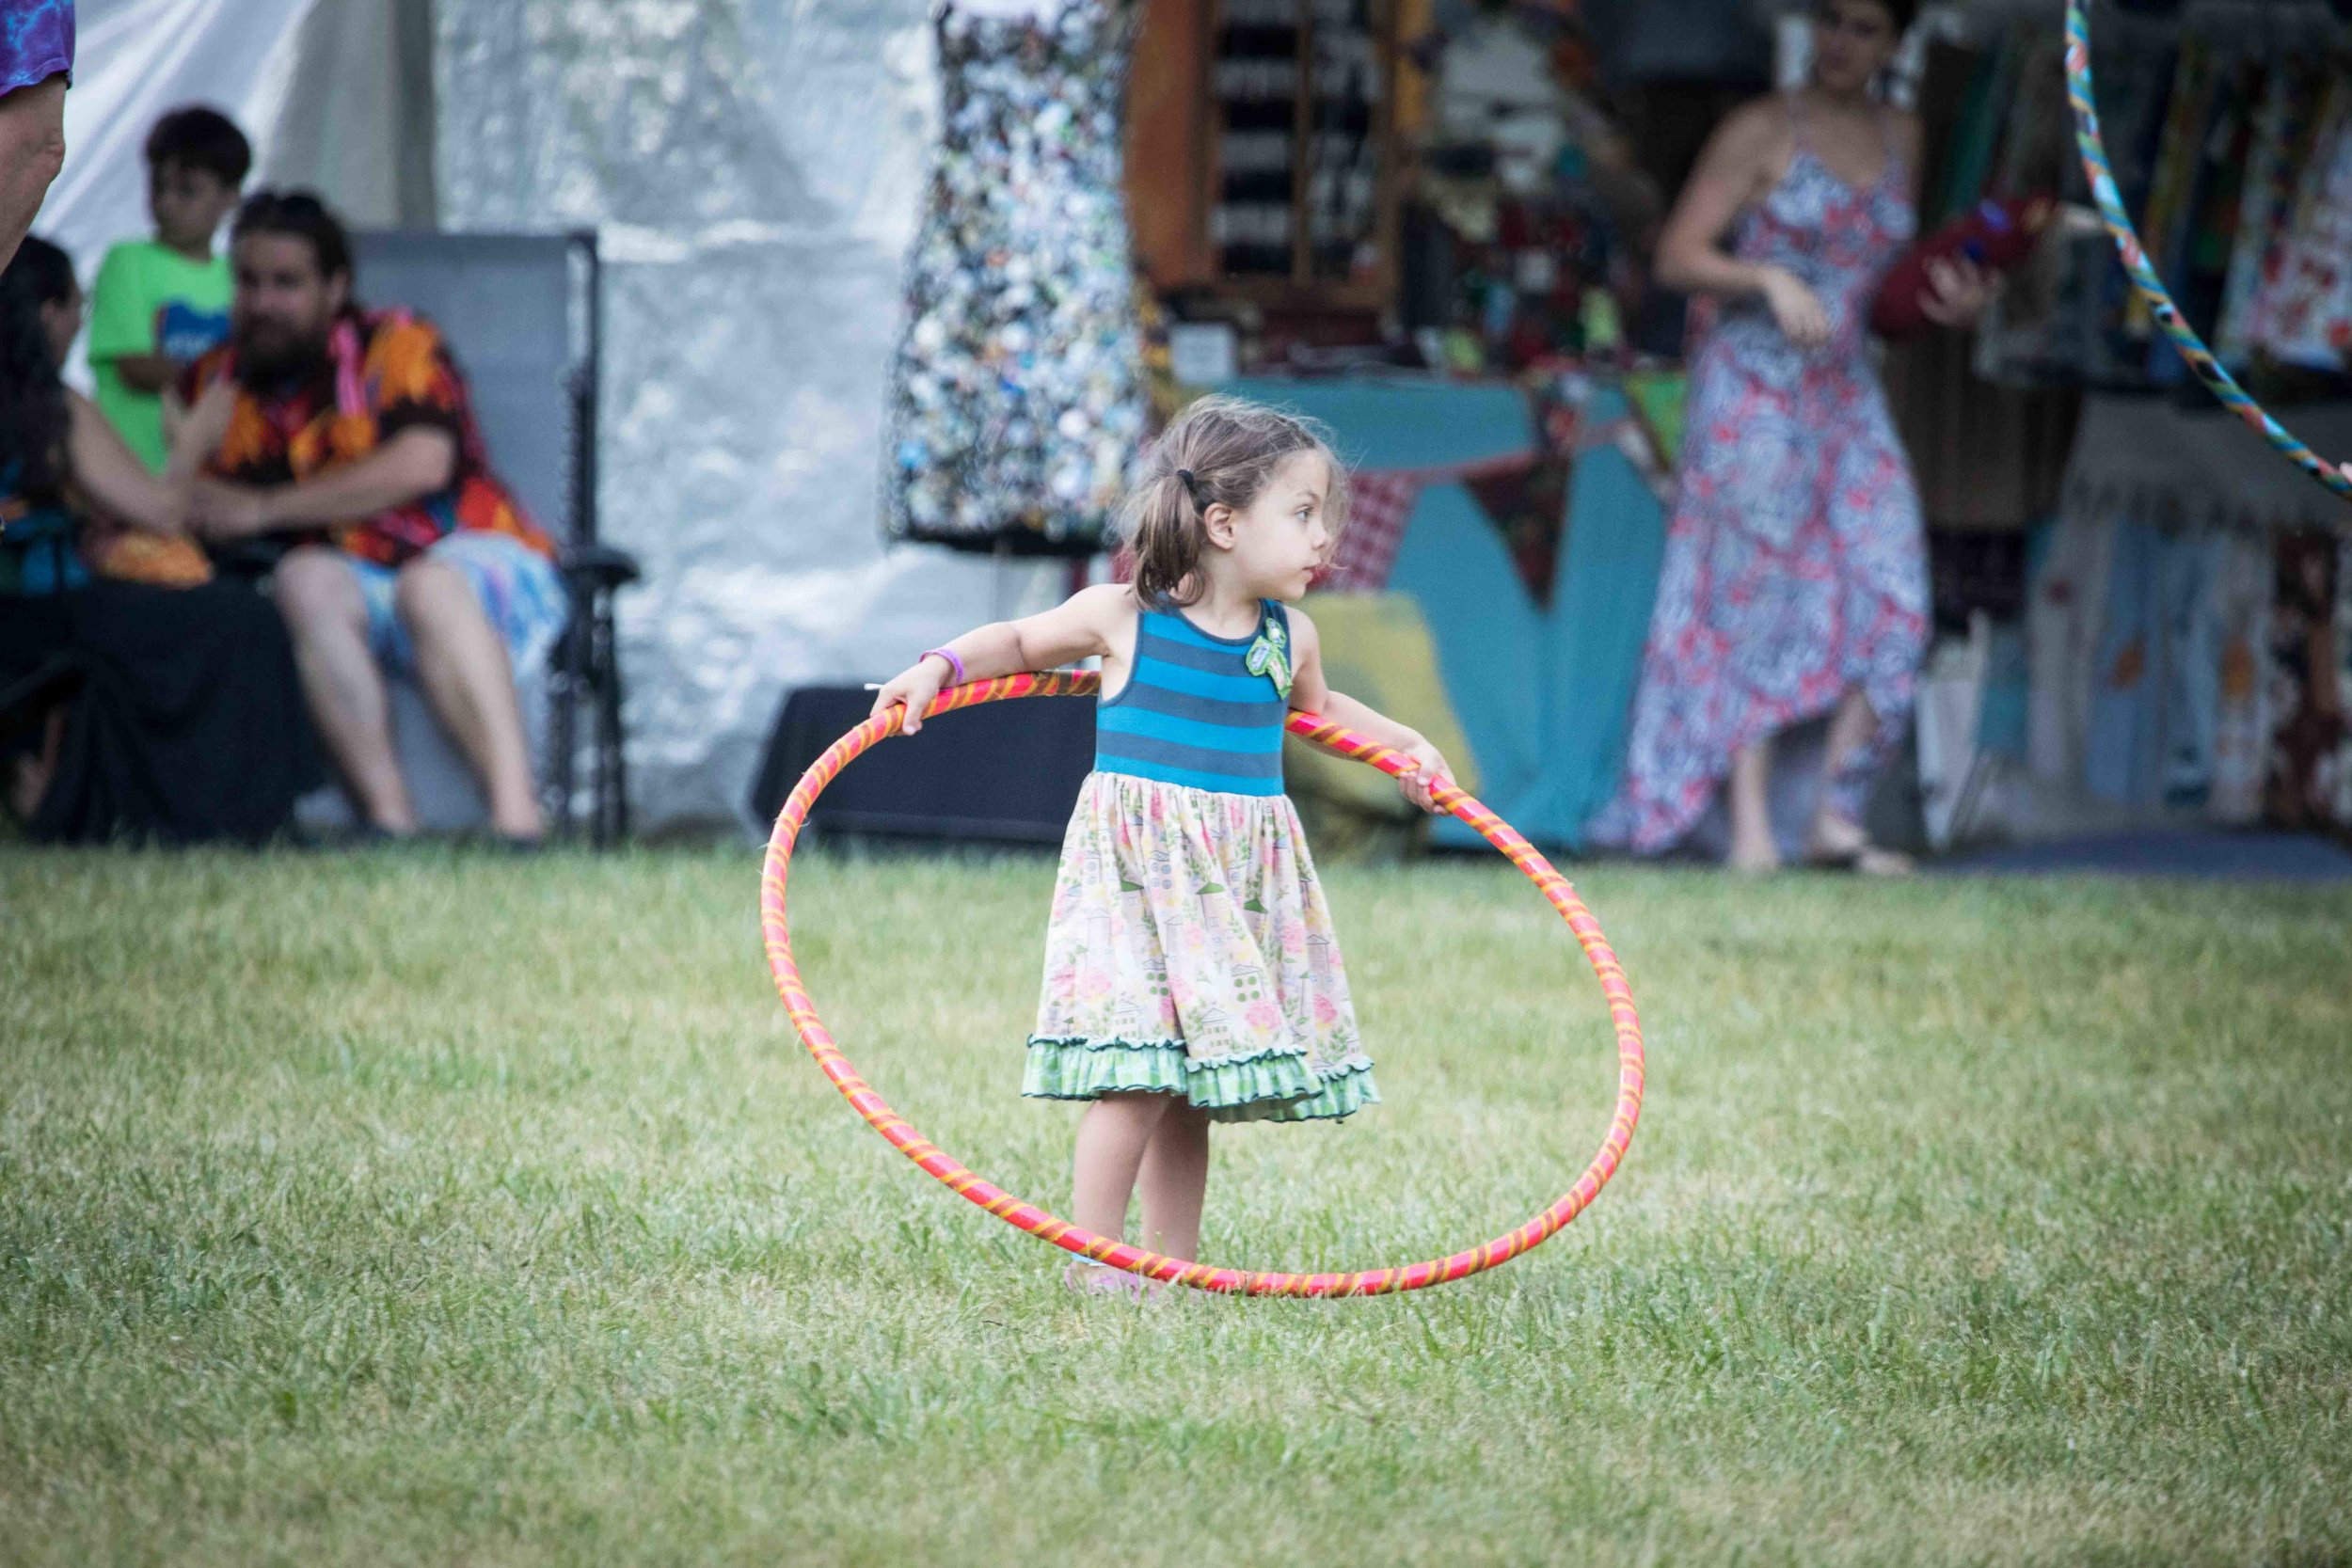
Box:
(89, 108), (254, 472)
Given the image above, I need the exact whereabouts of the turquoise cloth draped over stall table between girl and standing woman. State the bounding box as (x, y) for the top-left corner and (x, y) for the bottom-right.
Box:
(1391, 392), (1665, 851)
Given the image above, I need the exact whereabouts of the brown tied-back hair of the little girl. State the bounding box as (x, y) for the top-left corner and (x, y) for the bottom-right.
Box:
(1120, 397), (1348, 604)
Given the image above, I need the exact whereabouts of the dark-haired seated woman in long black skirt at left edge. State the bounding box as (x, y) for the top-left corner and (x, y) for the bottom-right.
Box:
(0, 240), (318, 842)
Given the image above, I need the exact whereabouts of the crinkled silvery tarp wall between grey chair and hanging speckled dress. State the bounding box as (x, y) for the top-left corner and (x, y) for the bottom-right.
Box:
(436, 0), (1066, 830)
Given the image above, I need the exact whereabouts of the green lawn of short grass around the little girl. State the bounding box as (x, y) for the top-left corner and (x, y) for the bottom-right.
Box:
(0, 851), (2352, 1566)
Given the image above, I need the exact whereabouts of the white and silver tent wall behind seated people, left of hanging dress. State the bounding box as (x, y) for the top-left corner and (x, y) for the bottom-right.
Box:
(38, 0), (1063, 830)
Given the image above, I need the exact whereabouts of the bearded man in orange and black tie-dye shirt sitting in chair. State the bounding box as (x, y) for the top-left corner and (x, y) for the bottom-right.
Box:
(172, 190), (567, 842)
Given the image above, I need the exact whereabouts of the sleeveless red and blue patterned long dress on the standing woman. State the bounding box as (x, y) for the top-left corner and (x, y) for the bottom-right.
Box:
(1590, 107), (1927, 853)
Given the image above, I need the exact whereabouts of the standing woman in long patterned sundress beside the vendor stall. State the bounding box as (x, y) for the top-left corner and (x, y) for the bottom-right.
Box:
(1593, 0), (1988, 872)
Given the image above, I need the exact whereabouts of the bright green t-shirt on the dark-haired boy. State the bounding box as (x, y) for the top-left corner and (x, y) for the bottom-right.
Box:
(89, 240), (230, 472)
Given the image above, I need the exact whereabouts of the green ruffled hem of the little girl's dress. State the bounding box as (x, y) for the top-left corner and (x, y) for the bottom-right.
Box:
(1021, 1039), (1381, 1121)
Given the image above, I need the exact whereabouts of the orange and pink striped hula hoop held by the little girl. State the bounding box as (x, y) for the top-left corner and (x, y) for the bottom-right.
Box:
(760, 673), (1642, 1295)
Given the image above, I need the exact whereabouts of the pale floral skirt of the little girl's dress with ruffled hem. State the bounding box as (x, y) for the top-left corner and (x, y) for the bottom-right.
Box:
(1021, 773), (1381, 1121)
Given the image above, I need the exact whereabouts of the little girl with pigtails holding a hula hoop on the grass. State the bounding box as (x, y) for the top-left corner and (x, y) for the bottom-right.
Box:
(875, 397), (1452, 1291)
